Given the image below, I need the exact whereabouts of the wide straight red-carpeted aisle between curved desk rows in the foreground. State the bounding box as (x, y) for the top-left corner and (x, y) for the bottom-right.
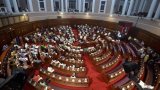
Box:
(83, 55), (107, 90)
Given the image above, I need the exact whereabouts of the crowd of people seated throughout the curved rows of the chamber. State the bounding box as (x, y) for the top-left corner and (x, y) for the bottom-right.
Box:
(0, 24), (159, 90)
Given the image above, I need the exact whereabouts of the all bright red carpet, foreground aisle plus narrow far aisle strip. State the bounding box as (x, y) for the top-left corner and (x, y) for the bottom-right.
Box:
(24, 29), (109, 90)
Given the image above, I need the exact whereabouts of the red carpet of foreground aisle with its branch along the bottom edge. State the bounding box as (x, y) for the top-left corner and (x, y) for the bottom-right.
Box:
(24, 55), (109, 90)
